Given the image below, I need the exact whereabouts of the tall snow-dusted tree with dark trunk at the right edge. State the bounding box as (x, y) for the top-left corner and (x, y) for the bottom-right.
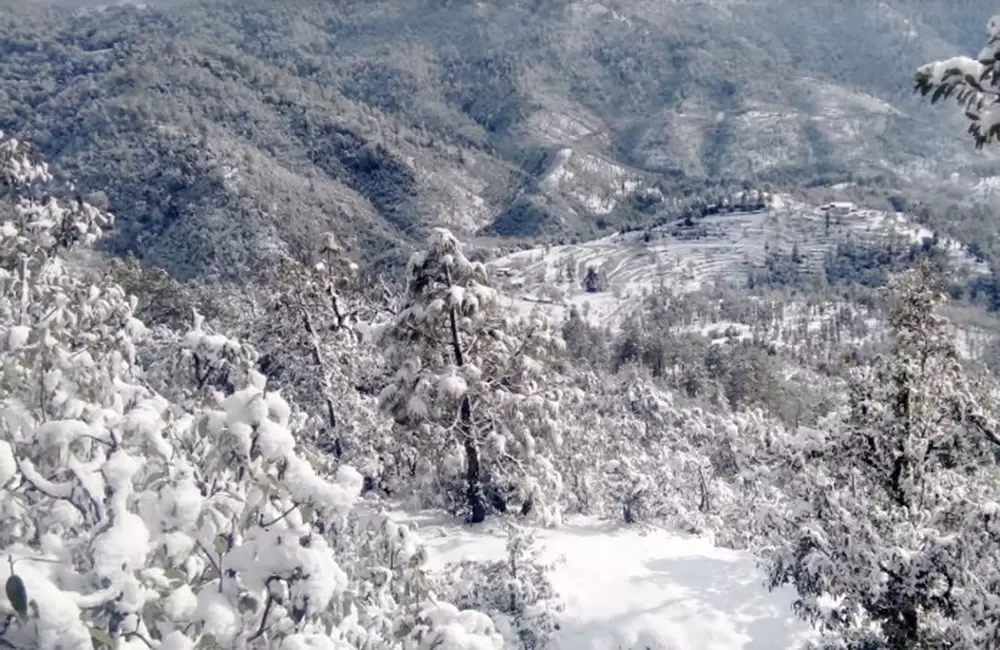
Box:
(766, 265), (1000, 650)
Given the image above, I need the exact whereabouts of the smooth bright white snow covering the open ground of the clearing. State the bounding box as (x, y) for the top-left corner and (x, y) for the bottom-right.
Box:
(391, 512), (812, 650)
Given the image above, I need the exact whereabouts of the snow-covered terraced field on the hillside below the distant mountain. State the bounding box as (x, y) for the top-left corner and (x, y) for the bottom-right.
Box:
(491, 195), (988, 327)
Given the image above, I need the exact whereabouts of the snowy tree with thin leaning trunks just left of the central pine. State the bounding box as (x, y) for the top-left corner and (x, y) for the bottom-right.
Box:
(225, 235), (397, 480)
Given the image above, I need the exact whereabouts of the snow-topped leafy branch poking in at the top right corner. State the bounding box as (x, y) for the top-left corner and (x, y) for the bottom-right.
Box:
(915, 14), (1000, 149)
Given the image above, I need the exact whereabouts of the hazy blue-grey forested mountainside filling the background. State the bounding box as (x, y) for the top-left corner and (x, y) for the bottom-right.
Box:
(0, 0), (995, 277)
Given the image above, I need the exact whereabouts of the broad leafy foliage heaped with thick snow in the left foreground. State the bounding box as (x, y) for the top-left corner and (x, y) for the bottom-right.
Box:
(0, 134), (500, 650)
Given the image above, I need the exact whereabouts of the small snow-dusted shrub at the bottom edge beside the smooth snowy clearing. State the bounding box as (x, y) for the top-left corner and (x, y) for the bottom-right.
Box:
(437, 523), (562, 650)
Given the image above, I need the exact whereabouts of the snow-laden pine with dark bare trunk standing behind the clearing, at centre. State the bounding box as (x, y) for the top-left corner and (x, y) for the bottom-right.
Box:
(379, 229), (565, 522)
